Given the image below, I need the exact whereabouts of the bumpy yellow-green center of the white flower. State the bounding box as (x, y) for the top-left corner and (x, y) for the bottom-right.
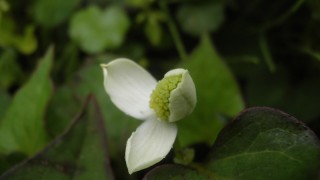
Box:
(149, 75), (182, 121)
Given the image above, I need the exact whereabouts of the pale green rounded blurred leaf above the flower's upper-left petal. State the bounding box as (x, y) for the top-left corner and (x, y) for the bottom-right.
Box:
(69, 6), (130, 53)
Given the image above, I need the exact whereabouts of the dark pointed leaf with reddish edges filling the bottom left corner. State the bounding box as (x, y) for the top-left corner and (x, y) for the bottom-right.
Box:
(0, 97), (114, 180)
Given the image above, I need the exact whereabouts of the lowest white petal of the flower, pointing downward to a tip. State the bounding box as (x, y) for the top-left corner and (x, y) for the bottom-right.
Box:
(125, 118), (177, 174)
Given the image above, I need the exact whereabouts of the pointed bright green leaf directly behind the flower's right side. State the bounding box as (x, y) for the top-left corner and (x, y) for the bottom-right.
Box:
(178, 36), (244, 147)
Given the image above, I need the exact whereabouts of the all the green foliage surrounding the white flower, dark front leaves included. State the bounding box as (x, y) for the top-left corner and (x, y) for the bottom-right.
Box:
(0, 0), (320, 179)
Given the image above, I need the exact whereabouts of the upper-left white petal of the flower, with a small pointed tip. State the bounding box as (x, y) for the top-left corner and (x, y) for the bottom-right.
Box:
(101, 58), (157, 119)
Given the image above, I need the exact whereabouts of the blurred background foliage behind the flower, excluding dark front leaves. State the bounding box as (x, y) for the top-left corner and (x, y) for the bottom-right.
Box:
(0, 0), (320, 178)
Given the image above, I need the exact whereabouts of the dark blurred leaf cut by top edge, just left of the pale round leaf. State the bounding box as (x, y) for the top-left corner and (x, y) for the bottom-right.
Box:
(32, 0), (80, 27)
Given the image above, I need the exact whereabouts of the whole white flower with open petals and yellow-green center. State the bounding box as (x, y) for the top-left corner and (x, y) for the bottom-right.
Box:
(101, 58), (197, 174)
